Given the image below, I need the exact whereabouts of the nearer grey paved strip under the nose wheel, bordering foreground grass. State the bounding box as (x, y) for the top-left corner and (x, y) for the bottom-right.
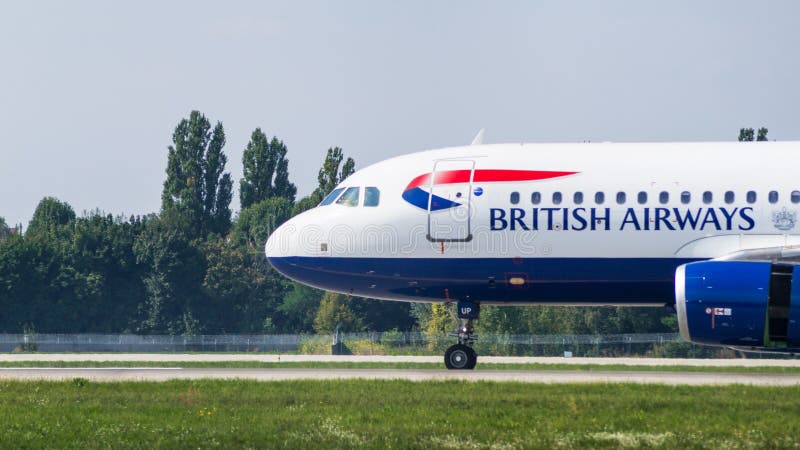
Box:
(0, 367), (800, 386)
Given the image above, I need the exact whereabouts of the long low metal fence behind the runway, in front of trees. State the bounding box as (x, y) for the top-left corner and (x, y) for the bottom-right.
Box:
(0, 331), (708, 356)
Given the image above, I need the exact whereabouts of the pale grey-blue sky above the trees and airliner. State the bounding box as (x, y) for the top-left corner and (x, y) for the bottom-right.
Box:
(0, 0), (800, 229)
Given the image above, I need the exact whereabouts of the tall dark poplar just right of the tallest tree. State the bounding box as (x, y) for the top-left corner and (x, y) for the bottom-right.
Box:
(239, 128), (297, 209)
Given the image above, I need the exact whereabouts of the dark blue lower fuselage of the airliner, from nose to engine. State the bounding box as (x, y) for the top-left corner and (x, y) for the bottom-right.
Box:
(269, 257), (696, 305)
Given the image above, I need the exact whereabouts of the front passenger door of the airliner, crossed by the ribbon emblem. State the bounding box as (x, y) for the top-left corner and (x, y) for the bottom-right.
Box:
(428, 160), (475, 242)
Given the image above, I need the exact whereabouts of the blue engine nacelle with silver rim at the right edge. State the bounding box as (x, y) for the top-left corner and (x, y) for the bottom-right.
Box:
(675, 261), (800, 350)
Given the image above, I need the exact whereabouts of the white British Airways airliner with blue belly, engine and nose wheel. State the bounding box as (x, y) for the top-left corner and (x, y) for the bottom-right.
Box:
(266, 142), (800, 369)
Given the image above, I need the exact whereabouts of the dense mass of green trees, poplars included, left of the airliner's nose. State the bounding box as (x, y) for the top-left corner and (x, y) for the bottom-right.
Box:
(0, 111), (400, 334)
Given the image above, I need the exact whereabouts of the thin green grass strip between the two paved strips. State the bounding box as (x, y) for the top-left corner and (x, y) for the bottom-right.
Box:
(0, 361), (800, 374)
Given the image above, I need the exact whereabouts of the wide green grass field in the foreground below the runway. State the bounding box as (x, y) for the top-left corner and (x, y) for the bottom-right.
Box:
(0, 379), (800, 449)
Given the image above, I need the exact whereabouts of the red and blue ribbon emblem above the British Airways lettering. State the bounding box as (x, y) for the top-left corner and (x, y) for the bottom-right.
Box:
(403, 169), (578, 211)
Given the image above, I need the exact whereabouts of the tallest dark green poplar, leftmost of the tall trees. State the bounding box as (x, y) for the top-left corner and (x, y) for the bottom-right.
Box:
(161, 111), (233, 237)
